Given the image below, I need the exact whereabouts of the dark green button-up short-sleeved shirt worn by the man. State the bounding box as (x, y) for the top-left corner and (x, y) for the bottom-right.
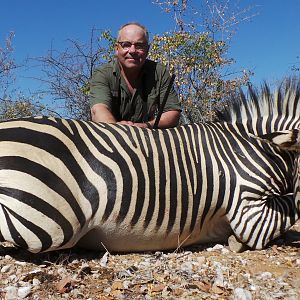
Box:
(90, 59), (181, 122)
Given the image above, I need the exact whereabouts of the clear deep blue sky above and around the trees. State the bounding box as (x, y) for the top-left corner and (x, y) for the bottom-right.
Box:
(0, 0), (300, 93)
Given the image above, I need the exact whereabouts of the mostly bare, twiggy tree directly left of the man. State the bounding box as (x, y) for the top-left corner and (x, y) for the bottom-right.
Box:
(33, 28), (114, 120)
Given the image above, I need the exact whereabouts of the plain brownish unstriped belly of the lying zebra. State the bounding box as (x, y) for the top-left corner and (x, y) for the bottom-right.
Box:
(77, 217), (232, 252)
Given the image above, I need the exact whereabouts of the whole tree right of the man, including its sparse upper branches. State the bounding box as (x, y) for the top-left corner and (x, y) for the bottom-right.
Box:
(150, 0), (254, 123)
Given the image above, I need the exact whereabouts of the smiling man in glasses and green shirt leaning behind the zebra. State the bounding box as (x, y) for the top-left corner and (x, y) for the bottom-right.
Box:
(90, 23), (181, 128)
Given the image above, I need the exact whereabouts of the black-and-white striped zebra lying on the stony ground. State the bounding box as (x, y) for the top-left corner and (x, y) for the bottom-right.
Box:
(0, 83), (300, 253)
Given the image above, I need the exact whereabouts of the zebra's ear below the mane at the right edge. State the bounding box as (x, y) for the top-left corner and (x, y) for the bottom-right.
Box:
(251, 129), (300, 151)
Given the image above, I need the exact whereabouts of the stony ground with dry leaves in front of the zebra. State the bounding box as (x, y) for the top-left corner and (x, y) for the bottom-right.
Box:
(0, 222), (300, 300)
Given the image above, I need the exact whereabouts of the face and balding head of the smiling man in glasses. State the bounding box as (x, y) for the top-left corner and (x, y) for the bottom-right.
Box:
(116, 25), (149, 71)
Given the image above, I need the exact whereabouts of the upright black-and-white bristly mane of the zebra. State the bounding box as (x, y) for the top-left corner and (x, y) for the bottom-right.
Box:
(216, 78), (300, 130)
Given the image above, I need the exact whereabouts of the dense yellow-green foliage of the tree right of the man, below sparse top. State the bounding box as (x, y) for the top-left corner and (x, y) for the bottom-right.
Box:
(150, 31), (248, 123)
